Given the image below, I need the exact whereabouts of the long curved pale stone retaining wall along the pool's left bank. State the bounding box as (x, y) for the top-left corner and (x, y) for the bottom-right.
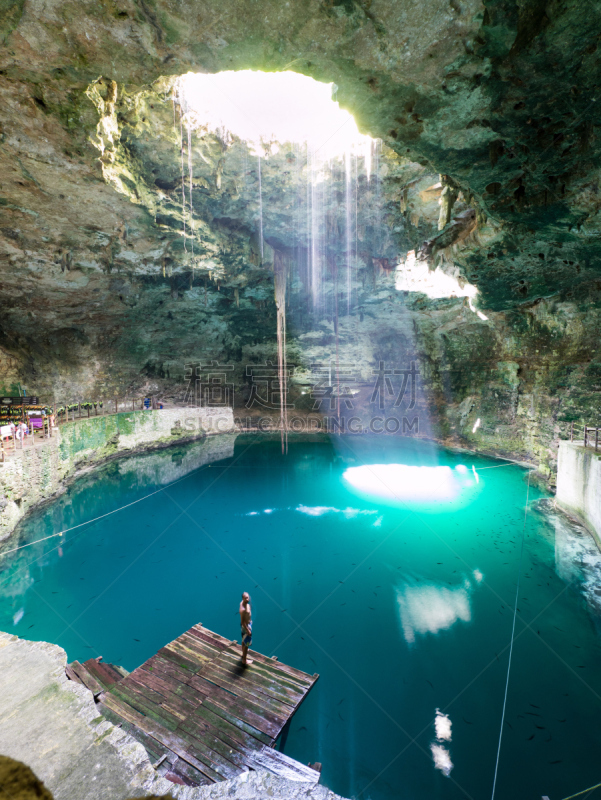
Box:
(0, 408), (234, 541)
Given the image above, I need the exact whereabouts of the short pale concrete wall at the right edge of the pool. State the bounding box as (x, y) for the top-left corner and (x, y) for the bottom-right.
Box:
(557, 442), (601, 544)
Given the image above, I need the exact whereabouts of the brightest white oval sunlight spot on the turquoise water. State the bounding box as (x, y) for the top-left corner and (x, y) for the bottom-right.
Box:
(343, 464), (476, 506)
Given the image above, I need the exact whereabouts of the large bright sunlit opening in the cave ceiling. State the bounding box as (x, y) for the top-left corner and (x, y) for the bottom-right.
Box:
(178, 70), (373, 164)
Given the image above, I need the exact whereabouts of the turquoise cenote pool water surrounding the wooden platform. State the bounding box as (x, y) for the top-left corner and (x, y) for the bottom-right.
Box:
(0, 436), (601, 800)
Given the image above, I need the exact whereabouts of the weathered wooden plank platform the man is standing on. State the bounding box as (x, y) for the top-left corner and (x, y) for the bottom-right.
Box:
(67, 625), (319, 786)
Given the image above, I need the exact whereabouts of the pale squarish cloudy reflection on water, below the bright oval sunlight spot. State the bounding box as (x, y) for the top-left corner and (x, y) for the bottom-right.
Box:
(396, 580), (472, 644)
